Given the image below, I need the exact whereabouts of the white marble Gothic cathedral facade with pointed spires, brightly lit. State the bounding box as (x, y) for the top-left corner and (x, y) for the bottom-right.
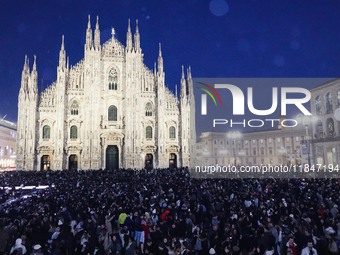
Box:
(16, 17), (196, 170)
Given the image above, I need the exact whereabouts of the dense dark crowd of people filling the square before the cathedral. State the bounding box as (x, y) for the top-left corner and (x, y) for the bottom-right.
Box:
(0, 168), (340, 255)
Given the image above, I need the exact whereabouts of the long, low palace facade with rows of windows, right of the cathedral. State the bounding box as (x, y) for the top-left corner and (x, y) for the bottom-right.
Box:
(196, 126), (305, 166)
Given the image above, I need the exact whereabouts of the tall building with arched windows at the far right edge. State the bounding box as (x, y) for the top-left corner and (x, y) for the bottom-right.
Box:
(311, 79), (340, 166)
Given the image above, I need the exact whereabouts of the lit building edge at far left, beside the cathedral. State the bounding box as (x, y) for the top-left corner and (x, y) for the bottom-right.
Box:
(0, 119), (17, 169)
